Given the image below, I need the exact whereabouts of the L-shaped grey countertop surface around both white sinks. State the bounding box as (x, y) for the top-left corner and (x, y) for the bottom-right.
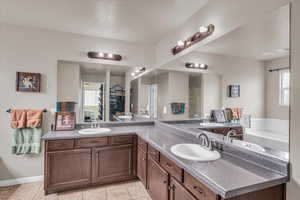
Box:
(42, 123), (288, 198)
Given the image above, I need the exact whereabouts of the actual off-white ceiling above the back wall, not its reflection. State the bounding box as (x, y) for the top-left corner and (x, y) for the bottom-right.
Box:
(0, 0), (208, 43)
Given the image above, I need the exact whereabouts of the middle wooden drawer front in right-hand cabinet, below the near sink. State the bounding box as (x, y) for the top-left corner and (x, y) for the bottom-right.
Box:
(160, 154), (183, 182)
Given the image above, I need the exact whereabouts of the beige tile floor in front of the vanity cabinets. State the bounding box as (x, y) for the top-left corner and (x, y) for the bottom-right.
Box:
(0, 181), (151, 200)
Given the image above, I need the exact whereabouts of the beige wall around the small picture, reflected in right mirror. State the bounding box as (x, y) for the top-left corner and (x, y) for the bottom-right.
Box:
(221, 58), (265, 118)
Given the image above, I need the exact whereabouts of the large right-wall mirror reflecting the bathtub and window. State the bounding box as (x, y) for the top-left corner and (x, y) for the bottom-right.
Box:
(133, 5), (290, 160)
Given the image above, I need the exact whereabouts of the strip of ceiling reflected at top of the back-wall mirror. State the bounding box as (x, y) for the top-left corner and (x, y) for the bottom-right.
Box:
(79, 62), (130, 76)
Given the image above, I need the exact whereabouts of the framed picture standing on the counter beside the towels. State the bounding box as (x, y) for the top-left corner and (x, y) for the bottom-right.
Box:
(54, 112), (76, 131)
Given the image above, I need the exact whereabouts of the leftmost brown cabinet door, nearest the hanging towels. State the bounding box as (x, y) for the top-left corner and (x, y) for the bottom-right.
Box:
(45, 149), (92, 193)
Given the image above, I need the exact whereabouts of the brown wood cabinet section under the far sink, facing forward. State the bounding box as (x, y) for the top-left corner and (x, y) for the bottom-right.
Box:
(44, 135), (137, 194)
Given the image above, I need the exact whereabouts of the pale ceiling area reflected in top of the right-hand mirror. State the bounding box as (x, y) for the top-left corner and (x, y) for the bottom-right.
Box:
(197, 5), (290, 60)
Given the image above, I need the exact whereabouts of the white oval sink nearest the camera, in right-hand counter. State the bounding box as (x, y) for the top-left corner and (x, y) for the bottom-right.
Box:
(171, 144), (221, 161)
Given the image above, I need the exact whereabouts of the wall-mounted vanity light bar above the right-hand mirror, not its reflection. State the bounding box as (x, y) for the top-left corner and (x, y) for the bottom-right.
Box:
(171, 24), (215, 55)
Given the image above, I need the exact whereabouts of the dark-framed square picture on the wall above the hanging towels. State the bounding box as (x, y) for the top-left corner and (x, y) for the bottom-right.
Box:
(16, 72), (41, 92)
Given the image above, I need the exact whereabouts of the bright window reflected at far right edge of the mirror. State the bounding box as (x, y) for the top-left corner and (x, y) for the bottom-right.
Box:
(279, 70), (290, 106)
